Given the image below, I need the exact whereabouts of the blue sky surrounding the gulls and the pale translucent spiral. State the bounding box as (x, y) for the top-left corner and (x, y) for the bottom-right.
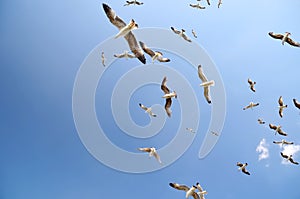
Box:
(0, 0), (300, 199)
